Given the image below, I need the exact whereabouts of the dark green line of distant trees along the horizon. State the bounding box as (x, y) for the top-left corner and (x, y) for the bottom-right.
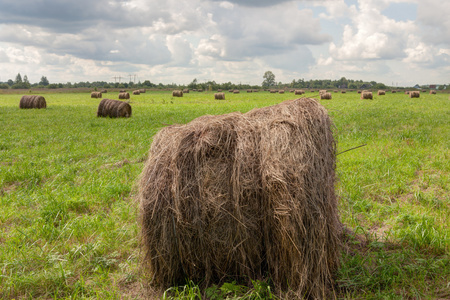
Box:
(0, 71), (450, 91)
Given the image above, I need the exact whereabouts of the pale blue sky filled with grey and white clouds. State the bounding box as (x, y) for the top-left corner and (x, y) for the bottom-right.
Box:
(0, 0), (450, 86)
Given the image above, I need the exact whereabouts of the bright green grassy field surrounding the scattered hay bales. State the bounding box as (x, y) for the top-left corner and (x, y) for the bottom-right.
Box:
(0, 91), (450, 299)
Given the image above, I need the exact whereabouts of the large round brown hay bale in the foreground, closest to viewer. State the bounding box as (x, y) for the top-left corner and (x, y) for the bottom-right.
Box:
(139, 98), (342, 298)
